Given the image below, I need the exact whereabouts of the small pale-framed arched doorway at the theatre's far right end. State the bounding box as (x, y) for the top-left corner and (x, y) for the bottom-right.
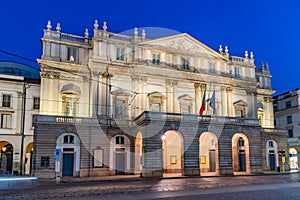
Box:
(266, 140), (279, 171)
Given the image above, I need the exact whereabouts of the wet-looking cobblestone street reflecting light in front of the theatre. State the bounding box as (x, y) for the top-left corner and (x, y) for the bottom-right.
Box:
(0, 173), (300, 200)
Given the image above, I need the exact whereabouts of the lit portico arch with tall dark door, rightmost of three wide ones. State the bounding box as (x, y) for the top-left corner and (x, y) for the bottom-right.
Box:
(232, 133), (250, 173)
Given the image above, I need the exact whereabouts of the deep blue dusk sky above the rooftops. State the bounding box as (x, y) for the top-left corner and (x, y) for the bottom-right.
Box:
(0, 0), (300, 94)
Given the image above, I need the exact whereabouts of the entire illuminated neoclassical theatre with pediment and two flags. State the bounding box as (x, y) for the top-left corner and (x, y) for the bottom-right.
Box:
(33, 21), (286, 177)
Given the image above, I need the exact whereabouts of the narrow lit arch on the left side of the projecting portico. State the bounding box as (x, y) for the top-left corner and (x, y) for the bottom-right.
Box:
(134, 132), (143, 174)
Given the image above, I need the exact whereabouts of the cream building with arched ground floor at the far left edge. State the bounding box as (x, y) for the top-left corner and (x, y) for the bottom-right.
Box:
(0, 61), (40, 175)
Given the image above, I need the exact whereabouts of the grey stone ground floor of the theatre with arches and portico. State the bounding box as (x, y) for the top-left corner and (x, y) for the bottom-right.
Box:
(32, 112), (287, 178)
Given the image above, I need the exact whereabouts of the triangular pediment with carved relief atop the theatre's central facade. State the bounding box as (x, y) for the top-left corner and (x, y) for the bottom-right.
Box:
(141, 33), (227, 60)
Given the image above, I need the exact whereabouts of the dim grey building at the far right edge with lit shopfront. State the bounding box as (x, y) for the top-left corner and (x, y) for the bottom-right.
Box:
(273, 88), (300, 170)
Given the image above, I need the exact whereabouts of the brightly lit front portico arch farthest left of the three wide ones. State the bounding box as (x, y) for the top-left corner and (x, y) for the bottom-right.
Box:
(162, 131), (184, 175)
